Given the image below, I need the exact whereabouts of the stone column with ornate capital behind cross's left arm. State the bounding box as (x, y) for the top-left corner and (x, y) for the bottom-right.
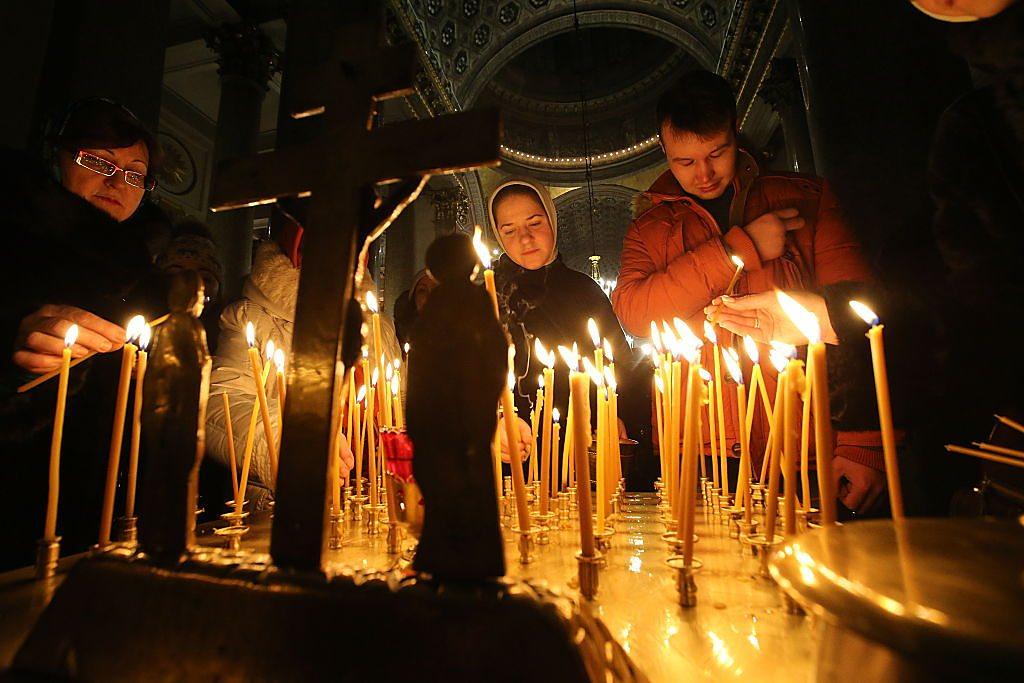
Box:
(206, 24), (281, 302)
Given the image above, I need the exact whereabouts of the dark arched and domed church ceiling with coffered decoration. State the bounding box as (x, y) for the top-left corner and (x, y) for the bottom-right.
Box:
(391, 0), (732, 185)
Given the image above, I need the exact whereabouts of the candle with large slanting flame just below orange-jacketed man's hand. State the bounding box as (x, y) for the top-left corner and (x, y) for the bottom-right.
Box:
(775, 291), (836, 526)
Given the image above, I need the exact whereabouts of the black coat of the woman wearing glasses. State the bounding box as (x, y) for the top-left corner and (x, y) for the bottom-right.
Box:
(0, 151), (169, 569)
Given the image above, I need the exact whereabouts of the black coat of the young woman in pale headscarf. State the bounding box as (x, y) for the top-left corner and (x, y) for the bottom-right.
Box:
(495, 255), (651, 464)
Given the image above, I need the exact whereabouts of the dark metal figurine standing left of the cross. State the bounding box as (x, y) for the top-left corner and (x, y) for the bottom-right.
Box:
(139, 271), (211, 563)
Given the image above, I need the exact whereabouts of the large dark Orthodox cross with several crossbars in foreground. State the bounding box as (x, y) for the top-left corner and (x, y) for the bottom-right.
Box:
(210, 2), (501, 570)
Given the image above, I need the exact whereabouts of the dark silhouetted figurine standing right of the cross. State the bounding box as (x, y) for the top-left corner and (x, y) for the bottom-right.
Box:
(408, 234), (508, 581)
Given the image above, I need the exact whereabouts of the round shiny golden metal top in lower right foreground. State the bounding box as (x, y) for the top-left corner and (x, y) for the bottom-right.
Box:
(771, 519), (1024, 667)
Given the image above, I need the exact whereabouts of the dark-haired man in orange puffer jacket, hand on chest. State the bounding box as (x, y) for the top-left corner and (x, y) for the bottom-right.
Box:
(611, 72), (885, 512)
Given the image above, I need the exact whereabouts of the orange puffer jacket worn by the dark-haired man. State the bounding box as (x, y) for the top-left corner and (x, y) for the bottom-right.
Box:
(611, 152), (884, 470)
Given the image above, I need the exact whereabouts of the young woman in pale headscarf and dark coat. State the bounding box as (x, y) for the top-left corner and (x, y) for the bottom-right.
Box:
(488, 179), (650, 485)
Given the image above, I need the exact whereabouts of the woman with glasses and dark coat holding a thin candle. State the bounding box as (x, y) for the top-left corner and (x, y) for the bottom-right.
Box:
(0, 98), (170, 569)
